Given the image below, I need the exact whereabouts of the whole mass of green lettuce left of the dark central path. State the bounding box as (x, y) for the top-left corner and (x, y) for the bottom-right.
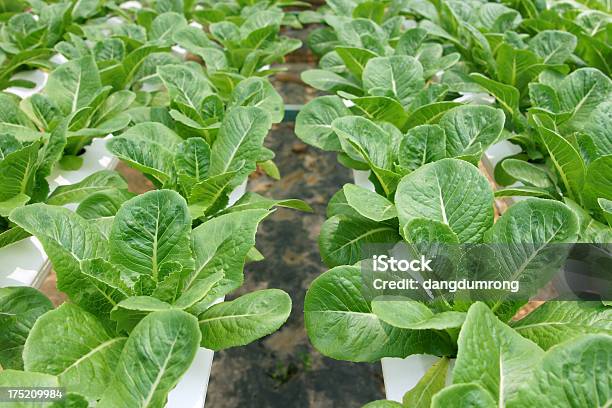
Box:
(0, 1), (310, 407)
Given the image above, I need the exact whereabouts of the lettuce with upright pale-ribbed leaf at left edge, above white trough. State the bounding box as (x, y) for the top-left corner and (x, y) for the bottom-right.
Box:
(0, 53), (134, 161)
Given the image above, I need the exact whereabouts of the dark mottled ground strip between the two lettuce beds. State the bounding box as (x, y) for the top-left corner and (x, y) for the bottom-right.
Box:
(206, 61), (384, 408)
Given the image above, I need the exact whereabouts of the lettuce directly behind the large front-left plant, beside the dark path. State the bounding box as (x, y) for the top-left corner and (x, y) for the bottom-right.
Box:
(105, 106), (310, 219)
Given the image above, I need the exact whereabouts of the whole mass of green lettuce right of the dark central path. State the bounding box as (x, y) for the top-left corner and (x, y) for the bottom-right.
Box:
(296, 0), (612, 407)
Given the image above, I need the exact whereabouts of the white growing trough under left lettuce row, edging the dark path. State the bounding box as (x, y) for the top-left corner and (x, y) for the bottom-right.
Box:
(166, 180), (247, 408)
